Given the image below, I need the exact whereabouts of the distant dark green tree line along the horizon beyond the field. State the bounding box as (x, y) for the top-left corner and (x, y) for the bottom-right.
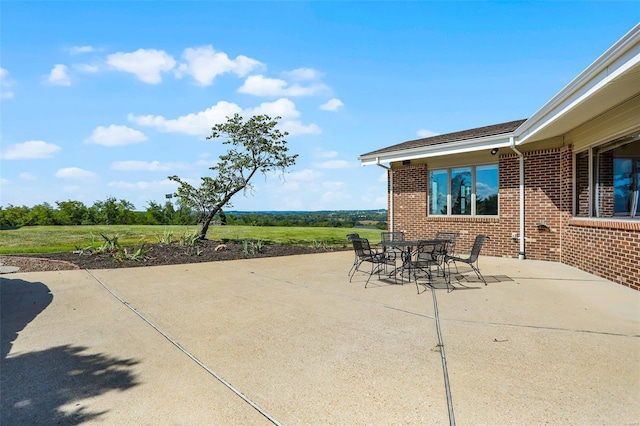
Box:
(0, 197), (387, 229)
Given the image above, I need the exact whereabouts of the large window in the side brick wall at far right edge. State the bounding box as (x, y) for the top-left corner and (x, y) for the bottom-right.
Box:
(574, 133), (640, 218)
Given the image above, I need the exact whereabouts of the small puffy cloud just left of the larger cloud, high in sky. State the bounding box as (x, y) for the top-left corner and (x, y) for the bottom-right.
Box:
(107, 49), (176, 84)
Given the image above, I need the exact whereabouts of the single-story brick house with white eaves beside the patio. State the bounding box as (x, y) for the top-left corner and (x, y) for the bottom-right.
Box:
(358, 24), (640, 290)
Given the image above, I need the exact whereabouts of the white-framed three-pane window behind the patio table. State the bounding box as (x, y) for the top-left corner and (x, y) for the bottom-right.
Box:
(429, 164), (498, 216)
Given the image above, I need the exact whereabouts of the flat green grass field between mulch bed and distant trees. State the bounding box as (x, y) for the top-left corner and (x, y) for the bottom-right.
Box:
(0, 225), (380, 254)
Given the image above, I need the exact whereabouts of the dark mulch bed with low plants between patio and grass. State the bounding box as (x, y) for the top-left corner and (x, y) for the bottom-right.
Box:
(0, 240), (349, 272)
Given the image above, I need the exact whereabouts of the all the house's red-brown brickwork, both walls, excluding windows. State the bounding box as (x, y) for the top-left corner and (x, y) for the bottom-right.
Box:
(389, 147), (640, 289)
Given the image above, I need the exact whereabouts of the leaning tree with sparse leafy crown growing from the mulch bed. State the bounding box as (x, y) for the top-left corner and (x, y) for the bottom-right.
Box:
(169, 114), (298, 239)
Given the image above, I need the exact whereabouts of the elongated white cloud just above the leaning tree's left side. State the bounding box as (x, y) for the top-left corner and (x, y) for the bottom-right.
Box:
(128, 101), (242, 136)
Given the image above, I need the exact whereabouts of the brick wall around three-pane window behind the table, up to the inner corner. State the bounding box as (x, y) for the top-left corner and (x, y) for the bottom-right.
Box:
(393, 154), (560, 261)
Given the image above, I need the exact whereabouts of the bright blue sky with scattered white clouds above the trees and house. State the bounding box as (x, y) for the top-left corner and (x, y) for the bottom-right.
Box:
(0, 1), (640, 211)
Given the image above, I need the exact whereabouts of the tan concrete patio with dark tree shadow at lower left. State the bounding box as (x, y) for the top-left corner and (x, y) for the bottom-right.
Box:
(0, 251), (640, 425)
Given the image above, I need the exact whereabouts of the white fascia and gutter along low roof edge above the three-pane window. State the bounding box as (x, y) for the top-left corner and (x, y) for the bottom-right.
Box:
(358, 133), (513, 166)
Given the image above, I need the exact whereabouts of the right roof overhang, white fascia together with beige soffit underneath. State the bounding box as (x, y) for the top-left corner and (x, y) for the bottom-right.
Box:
(514, 24), (640, 145)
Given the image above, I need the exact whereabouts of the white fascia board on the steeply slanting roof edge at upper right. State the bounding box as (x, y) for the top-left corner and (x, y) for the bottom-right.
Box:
(514, 24), (640, 145)
